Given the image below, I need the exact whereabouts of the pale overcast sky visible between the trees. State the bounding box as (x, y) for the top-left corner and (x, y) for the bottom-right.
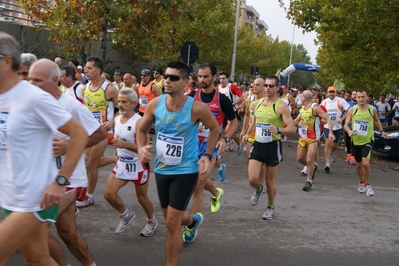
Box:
(246, 0), (318, 63)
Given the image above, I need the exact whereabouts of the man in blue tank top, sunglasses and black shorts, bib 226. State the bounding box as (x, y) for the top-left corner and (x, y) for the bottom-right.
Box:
(137, 62), (219, 265)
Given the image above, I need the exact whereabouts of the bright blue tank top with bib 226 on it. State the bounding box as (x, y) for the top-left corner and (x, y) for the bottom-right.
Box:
(154, 95), (199, 175)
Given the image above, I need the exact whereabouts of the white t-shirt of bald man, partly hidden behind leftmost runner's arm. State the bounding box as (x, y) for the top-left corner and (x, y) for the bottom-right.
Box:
(56, 93), (100, 188)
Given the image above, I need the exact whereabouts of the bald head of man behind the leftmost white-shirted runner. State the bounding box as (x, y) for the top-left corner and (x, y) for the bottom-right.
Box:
(28, 59), (61, 96)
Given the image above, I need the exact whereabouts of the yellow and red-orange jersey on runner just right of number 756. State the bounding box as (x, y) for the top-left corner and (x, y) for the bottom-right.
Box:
(298, 103), (321, 142)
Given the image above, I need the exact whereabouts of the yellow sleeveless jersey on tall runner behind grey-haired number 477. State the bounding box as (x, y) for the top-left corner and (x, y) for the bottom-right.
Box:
(83, 81), (114, 124)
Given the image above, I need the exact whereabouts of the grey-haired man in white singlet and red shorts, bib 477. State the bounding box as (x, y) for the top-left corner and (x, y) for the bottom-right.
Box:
(104, 88), (158, 237)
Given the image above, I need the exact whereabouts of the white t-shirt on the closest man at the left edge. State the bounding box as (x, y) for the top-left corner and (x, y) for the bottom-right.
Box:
(0, 80), (72, 212)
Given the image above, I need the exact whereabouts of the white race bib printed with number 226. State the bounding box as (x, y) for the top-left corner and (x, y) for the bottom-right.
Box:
(156, 133), (184, 165)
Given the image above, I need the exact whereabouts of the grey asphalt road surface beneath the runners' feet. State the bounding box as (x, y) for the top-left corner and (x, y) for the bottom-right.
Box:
(0, 137), (399, 266)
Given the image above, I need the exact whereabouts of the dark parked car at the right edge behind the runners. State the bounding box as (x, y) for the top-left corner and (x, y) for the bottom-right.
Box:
(373, 126), (399, 157)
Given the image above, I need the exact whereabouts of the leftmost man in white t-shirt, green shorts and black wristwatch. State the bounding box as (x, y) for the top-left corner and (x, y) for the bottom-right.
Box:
(0, 32), (88, 265)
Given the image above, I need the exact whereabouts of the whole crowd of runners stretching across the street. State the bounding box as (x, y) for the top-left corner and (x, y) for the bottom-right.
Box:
(0, 33), (399, 265)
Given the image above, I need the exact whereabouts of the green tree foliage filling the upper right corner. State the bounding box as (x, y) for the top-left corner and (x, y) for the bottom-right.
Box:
(279, 0), (399, 94)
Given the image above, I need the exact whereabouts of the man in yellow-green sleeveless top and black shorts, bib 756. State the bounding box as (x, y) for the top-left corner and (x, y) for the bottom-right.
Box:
(243, 76), (296, 220)
